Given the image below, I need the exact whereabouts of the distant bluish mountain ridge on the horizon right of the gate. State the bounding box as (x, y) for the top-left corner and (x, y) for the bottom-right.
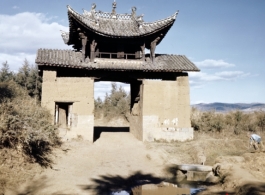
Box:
(191, 102), (265, 112)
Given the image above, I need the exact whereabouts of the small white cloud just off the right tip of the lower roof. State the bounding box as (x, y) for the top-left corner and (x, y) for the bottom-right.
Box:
(194, 59), (235, 69)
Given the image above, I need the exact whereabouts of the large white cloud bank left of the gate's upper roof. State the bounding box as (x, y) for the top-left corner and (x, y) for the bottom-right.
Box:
(0, 12), (71, 68)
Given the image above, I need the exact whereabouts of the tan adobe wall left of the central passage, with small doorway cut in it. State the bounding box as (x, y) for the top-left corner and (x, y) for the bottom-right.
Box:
(41, 70), (94, 142)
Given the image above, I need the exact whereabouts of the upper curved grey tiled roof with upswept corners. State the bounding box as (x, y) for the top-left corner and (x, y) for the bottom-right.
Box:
(62, 6), (178, 44)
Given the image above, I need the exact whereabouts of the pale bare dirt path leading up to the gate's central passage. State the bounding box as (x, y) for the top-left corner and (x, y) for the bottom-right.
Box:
(23, 133), (167, 195)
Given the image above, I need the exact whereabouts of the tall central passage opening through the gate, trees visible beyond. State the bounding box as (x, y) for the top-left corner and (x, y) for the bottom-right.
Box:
(93, 82), (130, 142)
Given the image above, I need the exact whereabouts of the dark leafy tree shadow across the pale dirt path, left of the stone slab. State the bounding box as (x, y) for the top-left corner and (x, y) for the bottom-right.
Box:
(80, 171), (163, 195)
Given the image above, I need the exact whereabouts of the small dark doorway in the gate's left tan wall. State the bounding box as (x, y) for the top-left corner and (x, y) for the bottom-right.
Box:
(54, 102), (73, 128)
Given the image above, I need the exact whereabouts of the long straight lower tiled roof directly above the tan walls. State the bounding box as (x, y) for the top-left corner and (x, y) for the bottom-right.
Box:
(36, 49), (200, 72)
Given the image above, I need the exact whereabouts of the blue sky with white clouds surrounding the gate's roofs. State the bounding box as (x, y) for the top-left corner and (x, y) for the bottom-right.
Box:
(0, 0), (265, 104)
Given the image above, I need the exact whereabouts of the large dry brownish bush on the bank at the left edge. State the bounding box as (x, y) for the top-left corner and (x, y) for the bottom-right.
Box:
(0, 82), (60, 194)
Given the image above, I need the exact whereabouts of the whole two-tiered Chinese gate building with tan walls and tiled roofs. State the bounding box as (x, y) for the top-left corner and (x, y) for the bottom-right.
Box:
(36, 2), (200, 142)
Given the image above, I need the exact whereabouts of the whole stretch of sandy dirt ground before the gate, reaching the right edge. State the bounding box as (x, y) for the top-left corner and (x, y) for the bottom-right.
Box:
(4, 119), (265, 195)
